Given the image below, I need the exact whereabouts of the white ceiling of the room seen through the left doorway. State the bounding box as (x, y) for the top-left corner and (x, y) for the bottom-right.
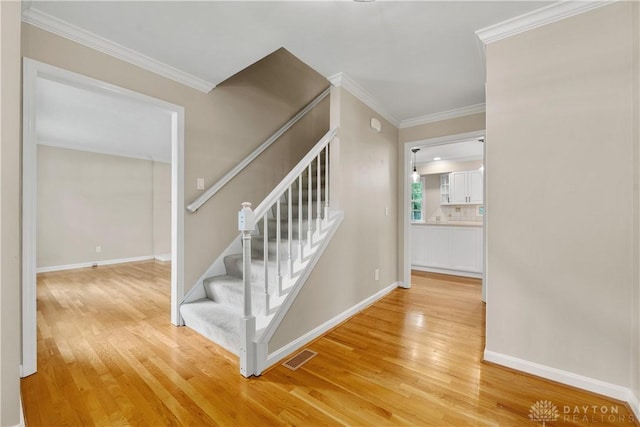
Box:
(36, 78), (171, 162)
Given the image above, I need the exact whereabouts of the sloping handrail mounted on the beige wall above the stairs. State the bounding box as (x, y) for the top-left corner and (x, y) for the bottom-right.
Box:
(187, 87), (331, 212)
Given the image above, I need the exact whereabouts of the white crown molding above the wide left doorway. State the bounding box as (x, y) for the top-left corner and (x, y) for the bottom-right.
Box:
(22, 8), (215, 93)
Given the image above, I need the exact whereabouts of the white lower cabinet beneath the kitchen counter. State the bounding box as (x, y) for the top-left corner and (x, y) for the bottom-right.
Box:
(411, 225), (483, 273)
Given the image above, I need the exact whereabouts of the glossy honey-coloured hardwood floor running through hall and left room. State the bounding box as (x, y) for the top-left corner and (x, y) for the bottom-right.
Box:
(22, 261), (635, 426)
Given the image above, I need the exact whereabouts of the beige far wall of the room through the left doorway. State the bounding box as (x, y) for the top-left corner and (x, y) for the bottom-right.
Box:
(37, 145), (171, 268)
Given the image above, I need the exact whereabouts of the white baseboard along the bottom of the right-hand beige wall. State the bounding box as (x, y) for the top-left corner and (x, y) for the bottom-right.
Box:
(484, 349), (640, 416)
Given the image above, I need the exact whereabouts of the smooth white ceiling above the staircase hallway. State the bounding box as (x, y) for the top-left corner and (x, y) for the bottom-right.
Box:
(25, 1), (552, 123)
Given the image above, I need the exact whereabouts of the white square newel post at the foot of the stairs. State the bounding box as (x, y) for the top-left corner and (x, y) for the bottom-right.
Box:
(238, 202), (257, 377)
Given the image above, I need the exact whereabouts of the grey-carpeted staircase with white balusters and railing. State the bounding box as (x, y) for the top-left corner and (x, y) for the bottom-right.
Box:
(180, 129), (342, 376)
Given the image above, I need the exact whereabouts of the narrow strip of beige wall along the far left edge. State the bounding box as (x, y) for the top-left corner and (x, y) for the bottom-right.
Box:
(0, 2), (21, 426)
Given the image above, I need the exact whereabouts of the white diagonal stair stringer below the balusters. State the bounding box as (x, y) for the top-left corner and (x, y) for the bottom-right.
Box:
(254, 209), (344, 375)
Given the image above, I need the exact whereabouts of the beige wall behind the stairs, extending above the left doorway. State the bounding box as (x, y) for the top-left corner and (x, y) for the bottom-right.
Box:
(22, 24), (328, 292)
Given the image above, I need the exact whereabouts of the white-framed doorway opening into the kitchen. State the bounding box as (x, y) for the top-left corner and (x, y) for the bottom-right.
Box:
(403, 131), (486, 302)
